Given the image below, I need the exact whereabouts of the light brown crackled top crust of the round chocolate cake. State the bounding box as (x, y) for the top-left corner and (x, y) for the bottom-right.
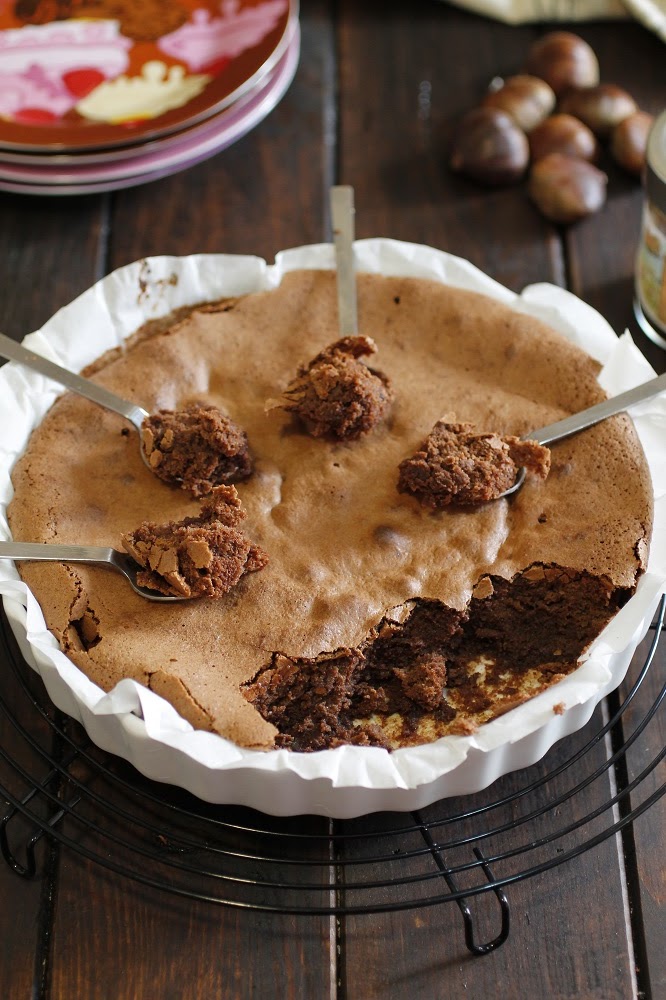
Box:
(9, 271), (652, 748)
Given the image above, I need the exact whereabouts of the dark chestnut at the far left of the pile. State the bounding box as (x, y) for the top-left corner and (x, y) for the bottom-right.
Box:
(449, 107), (530, 186)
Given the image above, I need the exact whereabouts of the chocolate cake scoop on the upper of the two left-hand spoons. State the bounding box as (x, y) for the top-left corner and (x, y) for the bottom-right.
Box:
(141, 404), (252, 497)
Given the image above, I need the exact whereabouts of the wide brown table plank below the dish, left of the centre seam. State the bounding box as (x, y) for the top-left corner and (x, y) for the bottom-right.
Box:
(51, 789), (334, 1000)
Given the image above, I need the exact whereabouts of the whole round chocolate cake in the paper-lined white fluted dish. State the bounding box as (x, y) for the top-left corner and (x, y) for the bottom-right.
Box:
(9, 271), (652, 751)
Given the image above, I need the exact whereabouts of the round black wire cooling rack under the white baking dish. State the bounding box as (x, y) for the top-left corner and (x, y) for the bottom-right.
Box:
(0, 598), (666, 955)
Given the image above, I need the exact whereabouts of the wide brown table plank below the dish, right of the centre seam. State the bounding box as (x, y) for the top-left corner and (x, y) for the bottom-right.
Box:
(342, 712), (634, 1000)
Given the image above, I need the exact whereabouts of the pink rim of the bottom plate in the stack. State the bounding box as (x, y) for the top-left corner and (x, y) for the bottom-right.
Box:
(0, 25), (300, 194)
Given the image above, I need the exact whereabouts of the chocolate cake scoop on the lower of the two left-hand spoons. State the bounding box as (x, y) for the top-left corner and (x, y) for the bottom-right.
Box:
(121, 486), (268, 598)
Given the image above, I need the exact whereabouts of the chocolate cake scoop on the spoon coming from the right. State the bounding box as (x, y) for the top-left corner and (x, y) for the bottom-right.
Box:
(398, 420), (550, 509)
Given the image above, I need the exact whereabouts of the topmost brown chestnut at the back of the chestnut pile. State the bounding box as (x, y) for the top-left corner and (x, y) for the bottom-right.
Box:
(525, 31), (599, 96)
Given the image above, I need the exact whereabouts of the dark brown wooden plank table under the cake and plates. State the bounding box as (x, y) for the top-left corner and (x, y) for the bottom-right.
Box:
(0, 0), (666, 1000)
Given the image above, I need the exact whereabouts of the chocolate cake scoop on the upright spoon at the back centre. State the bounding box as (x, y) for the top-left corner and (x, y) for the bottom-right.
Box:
(267, 337), (393, 441)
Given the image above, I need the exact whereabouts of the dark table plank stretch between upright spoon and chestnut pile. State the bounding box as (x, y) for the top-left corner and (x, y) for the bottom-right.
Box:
(339, 0), (564, 291)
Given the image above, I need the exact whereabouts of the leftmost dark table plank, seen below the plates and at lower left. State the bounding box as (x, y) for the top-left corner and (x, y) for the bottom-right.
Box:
(0, 186), (104, 1000)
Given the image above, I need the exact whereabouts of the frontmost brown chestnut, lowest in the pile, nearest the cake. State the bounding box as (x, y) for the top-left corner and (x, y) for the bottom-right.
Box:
(527, 153), (608, 224)
